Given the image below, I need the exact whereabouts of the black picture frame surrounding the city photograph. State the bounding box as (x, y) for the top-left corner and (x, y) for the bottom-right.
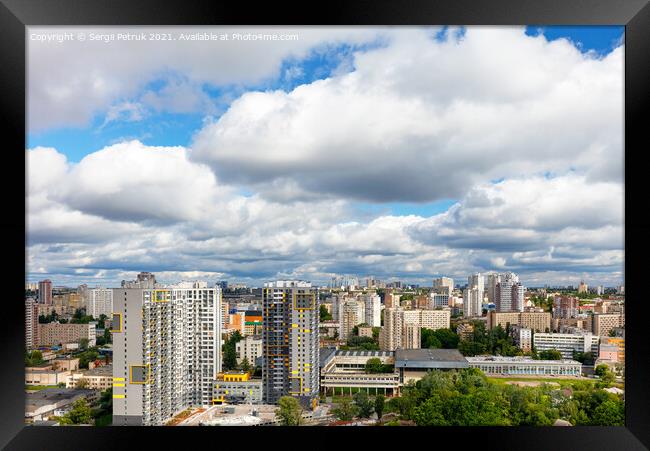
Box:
(0, 0), (650, 451)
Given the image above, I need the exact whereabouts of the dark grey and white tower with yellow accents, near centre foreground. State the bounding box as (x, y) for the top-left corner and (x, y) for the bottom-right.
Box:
(262, 281), (319, 408)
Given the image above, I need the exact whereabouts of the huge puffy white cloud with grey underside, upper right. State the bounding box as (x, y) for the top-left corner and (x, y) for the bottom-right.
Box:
(191, 27), (623, 202)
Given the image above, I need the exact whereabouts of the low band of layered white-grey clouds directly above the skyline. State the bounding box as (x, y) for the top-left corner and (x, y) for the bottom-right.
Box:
(27, 142), (623, 283)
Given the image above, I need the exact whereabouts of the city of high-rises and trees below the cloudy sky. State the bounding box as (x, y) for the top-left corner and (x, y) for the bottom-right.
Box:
(25, 272), (625, 426)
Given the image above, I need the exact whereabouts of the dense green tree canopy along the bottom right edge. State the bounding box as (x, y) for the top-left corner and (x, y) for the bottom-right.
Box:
(386, 368), (624, 426)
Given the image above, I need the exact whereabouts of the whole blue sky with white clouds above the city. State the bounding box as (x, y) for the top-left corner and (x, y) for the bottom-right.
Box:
(26, 27), (624, 286)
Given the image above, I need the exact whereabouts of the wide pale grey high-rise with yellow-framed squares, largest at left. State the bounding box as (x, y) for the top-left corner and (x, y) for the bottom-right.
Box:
(111, 279), (221, 426)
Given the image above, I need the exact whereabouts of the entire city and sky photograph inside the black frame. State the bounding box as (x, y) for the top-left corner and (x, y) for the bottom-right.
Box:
(24, 26), (624, 427)
